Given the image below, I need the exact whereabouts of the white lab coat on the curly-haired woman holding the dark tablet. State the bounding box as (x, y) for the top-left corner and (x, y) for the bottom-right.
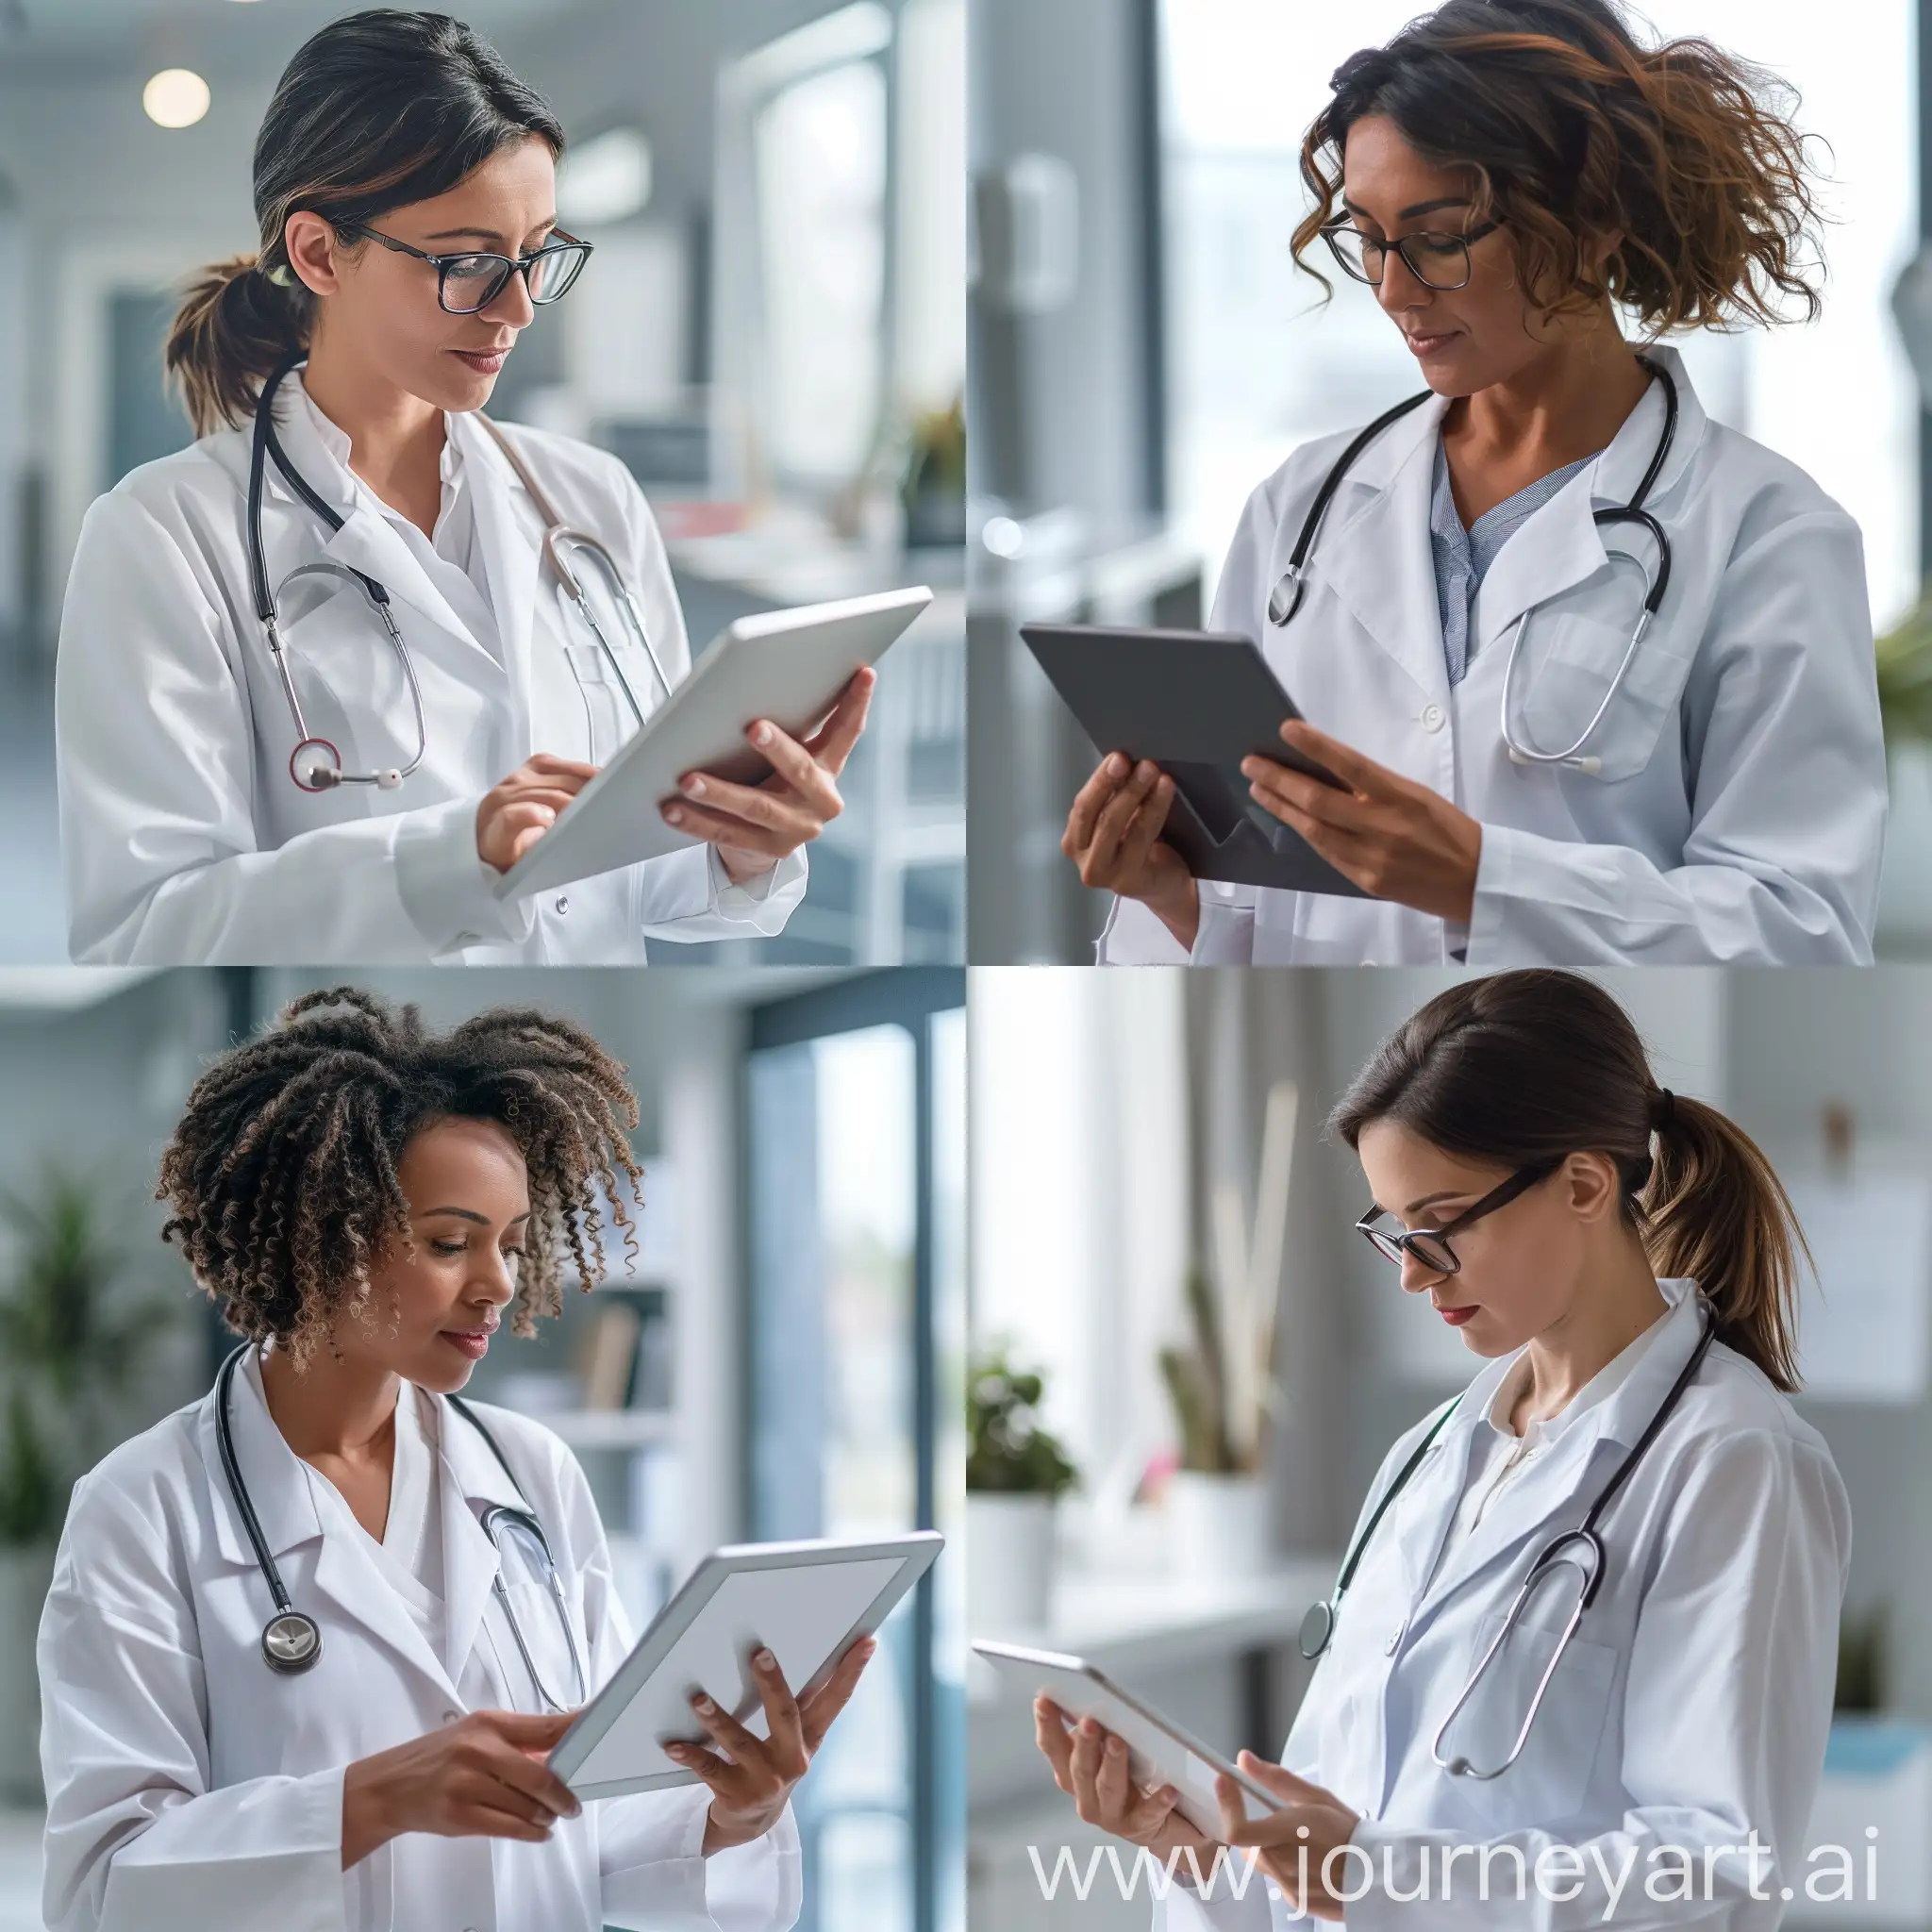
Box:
(1097, 348), (1888, 966)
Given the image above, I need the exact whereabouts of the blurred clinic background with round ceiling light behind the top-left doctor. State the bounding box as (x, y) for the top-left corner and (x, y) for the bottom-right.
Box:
(0, 0), (966, 966)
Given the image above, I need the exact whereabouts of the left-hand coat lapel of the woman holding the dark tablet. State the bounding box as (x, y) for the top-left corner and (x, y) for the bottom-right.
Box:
(1307, 396), (1449, 703)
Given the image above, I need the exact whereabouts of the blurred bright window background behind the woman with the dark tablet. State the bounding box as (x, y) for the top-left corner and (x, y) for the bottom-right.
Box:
(968, 0), (1932, 962)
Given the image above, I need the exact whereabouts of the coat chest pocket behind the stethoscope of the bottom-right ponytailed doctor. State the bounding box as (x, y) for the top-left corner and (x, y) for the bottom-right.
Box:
(1438, 1611), (1617, 1825)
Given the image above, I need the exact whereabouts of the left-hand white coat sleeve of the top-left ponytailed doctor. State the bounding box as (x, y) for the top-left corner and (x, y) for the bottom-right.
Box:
(54, 489), (533, 966)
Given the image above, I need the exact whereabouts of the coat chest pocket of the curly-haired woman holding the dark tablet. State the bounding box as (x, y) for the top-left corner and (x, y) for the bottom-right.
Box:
(1503, 602), (1690, 782)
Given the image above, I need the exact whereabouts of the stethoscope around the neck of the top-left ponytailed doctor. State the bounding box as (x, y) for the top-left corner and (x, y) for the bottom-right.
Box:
(247, 356), (671, 792)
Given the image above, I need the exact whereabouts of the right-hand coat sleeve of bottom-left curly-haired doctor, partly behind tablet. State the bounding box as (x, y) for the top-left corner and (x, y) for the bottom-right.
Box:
(564, 1457), (804, 1932)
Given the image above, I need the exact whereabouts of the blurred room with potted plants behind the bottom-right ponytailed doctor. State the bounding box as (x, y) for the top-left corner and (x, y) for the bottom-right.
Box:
(966, 966), (1932, 1932)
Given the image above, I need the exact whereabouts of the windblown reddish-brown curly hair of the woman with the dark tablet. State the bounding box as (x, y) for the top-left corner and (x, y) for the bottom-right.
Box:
(1294, 0), (1820, 334)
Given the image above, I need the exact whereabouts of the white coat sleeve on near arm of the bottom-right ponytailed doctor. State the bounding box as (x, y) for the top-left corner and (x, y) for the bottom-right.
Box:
(1337, 1430), (1857, 1932)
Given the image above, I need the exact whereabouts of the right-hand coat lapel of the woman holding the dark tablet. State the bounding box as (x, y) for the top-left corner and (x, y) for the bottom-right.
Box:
(1473, 336), (1704, 651)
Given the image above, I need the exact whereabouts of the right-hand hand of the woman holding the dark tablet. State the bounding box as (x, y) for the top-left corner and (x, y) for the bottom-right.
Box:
(1241, 719), (1482, 924)
